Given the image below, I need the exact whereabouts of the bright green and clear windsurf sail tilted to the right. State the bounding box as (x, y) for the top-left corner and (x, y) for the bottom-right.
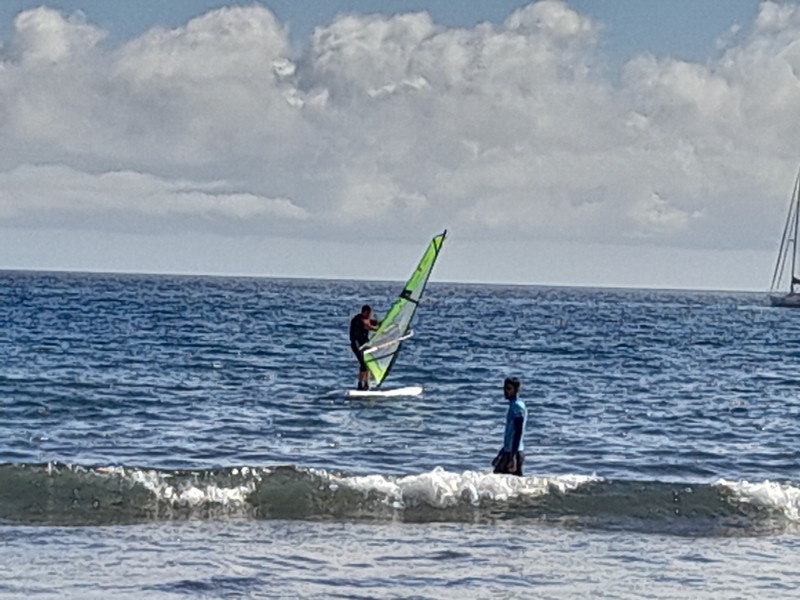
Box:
(363, 230), (447, 387)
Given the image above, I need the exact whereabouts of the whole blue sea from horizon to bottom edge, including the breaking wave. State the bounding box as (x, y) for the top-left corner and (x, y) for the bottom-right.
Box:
(0, 272), (800, 598)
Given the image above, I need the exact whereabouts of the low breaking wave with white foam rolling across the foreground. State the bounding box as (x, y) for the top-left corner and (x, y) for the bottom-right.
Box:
(0, 463), (800, 536)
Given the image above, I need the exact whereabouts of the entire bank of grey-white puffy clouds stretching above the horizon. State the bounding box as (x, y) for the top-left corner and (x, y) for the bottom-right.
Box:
(0, 0), (800, 282)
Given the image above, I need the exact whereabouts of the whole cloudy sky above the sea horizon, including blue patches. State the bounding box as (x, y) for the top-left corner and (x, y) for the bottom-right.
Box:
(0, 0), (800, 291)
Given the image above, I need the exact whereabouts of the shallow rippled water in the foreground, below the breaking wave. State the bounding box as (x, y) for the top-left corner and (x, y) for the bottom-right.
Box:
(0, 520), (800, 599)
